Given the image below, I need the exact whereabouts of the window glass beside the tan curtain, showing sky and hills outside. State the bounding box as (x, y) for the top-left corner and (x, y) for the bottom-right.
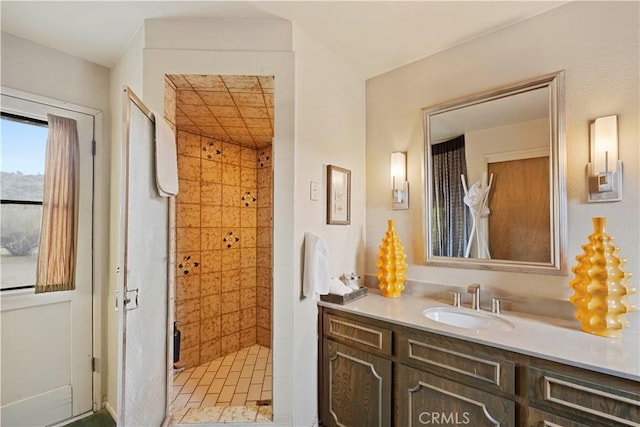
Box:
(0, 112), (48, 290)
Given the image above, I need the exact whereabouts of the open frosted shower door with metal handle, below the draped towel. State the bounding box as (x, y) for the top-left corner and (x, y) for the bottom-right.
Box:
(117, 89), (169, 427)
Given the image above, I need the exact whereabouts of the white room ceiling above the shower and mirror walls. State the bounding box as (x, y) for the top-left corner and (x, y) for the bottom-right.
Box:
(0, 0), (567, 79)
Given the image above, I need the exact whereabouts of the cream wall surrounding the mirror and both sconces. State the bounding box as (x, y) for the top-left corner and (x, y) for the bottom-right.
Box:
(366, 2), (640, 301)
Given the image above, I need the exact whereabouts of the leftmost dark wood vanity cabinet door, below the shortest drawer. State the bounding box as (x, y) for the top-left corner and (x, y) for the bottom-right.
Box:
(322, 338), (392, 427)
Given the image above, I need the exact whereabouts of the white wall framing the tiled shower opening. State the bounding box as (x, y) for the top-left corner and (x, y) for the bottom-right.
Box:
(142, 20), (294, 425)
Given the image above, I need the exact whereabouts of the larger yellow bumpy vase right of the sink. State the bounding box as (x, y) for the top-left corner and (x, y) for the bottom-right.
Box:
(569, 217), (636, 338)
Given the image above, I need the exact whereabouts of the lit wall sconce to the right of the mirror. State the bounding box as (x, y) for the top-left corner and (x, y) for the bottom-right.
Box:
(587, 116), (622, 202)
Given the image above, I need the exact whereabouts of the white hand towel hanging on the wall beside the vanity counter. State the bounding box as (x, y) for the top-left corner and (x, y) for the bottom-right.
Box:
(302, 231), (329, 299)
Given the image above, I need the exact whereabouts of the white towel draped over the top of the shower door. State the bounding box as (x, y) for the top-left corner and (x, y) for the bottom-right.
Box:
(153, 113), (178, 197)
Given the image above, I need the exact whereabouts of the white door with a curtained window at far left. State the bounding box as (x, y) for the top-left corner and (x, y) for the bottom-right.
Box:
(0, 89), (94, 426)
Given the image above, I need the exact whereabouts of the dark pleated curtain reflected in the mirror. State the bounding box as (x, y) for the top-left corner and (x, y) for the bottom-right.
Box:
(431, 135), (469, 257)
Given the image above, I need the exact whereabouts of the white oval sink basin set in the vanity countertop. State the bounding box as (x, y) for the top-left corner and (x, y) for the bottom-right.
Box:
(422, 307), (515, 331)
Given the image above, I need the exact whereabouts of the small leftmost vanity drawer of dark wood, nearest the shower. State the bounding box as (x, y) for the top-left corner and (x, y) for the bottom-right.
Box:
(323, 314), (392, 356)
